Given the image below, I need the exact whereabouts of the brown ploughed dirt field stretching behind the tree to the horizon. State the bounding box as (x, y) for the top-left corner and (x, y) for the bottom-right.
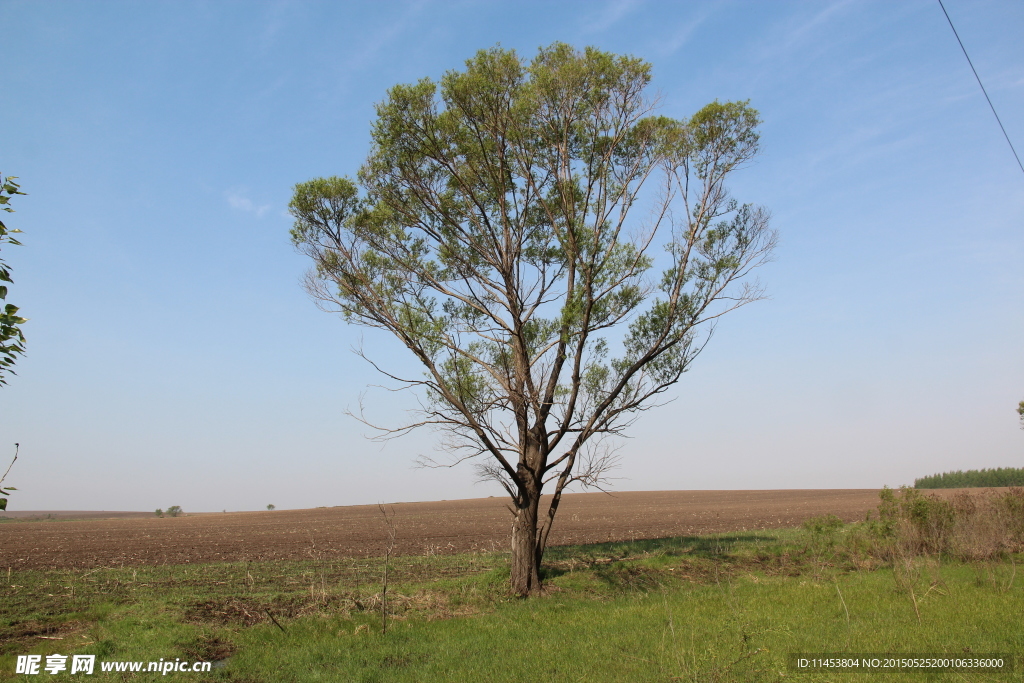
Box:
(0, 489), (991, 569)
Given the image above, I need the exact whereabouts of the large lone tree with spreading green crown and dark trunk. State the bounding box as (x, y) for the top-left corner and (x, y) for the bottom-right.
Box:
(290, 43), (775, 596)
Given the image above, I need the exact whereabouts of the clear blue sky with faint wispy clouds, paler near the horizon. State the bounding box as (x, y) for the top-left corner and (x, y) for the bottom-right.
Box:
(0, 0), (1024, 511)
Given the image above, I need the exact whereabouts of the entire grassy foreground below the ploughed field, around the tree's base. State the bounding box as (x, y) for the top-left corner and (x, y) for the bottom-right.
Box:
(0, 499), (1024, 682)
